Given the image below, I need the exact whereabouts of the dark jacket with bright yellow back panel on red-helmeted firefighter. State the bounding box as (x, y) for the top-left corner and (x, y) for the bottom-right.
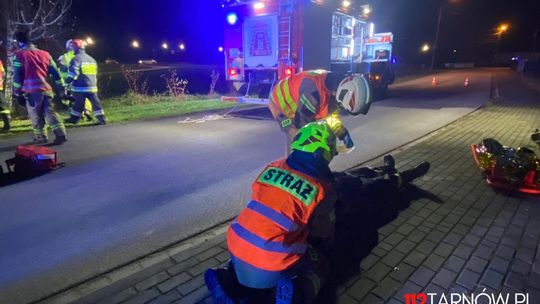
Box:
(67, 50), (98, 93)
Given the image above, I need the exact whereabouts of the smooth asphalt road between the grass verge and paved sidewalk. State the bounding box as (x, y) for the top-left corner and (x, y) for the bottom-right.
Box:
(0, 70), (498, 303)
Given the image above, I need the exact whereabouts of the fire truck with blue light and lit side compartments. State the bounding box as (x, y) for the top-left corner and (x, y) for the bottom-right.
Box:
(222, 0), (394, 103)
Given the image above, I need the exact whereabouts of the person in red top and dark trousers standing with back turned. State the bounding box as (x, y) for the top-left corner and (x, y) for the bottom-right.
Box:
(13, 32), (67, 145)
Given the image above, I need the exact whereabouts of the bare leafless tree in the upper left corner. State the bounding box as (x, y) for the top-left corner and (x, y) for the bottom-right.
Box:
(0, 0), (72, 111)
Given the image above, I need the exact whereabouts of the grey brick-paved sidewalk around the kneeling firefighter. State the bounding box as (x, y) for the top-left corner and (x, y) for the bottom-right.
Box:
(35, 73), (540, 304)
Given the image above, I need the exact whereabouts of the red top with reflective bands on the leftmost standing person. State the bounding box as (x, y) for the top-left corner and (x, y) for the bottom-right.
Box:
(13, 45), (62, 93)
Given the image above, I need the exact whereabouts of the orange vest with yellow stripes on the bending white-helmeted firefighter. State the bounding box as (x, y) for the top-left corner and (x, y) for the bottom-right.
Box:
(270, 70), (332, 120)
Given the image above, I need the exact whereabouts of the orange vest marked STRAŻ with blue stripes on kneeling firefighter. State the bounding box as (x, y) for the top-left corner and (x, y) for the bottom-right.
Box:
(227, 159), (328, 271)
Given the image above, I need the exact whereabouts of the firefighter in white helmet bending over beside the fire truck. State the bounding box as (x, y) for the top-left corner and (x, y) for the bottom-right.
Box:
(269, 70), (371, 154)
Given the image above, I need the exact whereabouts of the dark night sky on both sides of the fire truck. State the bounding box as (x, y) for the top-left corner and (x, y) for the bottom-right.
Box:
(67, 0), (540, 64)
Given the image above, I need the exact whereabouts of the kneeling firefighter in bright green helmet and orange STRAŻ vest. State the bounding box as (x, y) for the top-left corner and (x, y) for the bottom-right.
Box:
(205, 121), (337, 303)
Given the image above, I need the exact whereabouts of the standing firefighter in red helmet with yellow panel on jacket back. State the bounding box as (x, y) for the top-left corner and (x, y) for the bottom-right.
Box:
(66, 39), (106, 125)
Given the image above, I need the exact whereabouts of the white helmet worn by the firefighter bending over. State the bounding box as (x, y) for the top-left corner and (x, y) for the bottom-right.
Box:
(336, 74), (371, 115)
